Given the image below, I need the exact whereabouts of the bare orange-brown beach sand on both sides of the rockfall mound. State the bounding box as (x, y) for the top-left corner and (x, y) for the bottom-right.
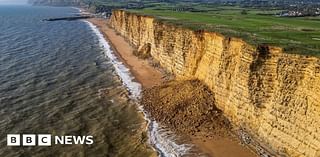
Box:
(88, 18), (257, 157)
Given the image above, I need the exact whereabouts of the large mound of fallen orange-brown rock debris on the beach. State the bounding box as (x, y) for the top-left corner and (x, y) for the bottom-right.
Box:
(141, 80), (231, 137)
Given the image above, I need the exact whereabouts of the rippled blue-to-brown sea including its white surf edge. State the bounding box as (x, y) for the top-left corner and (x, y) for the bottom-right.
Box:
(0, 5), (191, 157)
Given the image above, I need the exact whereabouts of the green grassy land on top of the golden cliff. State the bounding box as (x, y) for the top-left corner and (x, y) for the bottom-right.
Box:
(129, 6), (320, 57)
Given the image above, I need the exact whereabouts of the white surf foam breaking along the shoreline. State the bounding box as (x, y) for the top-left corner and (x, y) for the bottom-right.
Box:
(85, 21), (192, 157)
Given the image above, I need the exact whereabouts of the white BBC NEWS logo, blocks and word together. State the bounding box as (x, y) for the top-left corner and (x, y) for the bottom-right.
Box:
(7, 134), (93, 146)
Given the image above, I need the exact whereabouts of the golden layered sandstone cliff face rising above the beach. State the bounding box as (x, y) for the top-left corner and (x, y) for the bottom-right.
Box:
(110, 11), (320, 157)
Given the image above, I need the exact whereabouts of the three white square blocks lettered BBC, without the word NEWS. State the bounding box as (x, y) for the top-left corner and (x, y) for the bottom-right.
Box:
(7, 134), (51, 146)
